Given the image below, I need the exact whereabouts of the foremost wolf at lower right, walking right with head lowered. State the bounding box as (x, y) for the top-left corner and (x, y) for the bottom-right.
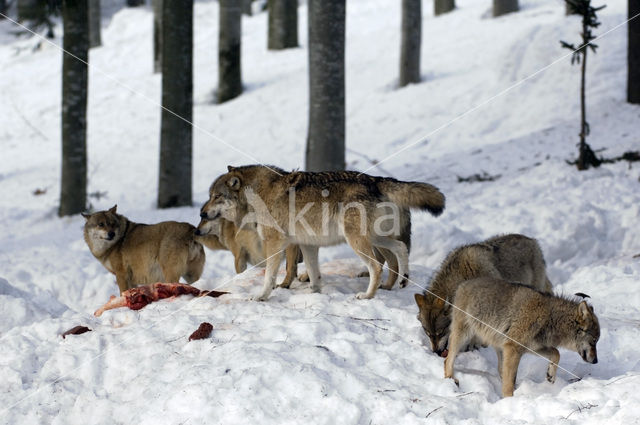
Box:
(444, 277), (600, 397)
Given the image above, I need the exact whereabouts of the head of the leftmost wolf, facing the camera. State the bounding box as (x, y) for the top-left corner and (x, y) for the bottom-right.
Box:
(82, 205), (127, 254)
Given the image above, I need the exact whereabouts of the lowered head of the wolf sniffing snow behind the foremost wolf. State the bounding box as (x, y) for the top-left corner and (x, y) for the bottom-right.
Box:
(415, 294), (451, 357)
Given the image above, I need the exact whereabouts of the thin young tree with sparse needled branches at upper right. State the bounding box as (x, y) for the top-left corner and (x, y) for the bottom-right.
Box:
(560, 0), (605, 170)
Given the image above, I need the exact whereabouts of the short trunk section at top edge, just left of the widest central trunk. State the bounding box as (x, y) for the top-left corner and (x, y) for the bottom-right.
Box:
(267, 0), (298, 50)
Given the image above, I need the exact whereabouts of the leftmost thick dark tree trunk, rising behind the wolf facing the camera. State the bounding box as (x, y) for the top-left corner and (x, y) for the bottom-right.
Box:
(58, 0), (89, 216)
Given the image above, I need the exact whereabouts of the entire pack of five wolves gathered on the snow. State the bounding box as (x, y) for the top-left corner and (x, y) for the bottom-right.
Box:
(83, 165), (600, 397)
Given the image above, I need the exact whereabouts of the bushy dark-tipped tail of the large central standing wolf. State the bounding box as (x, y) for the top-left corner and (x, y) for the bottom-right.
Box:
(378, 179), (444, 216)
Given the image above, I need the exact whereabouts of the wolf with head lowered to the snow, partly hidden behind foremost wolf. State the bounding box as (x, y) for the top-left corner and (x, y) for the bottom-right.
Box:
(415, 234), (552, 356)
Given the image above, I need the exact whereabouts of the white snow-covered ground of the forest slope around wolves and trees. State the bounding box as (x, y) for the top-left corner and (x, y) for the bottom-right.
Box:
(0, 0), (640, 424)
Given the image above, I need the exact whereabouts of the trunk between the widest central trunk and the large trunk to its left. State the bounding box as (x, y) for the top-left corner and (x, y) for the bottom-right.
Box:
(218, 0), (242, 103)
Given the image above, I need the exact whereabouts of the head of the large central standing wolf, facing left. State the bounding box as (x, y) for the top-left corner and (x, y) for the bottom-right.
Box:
(198, 166), (243, 227)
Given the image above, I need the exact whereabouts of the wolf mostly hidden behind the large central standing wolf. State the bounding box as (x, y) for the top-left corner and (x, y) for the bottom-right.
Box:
(195, 217), (307, 288)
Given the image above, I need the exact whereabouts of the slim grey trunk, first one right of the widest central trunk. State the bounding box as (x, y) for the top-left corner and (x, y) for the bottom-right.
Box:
(400, 0), (422, 87)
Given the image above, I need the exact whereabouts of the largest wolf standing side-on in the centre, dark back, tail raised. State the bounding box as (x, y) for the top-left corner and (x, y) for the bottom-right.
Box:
(202, 165), (445, 300)
